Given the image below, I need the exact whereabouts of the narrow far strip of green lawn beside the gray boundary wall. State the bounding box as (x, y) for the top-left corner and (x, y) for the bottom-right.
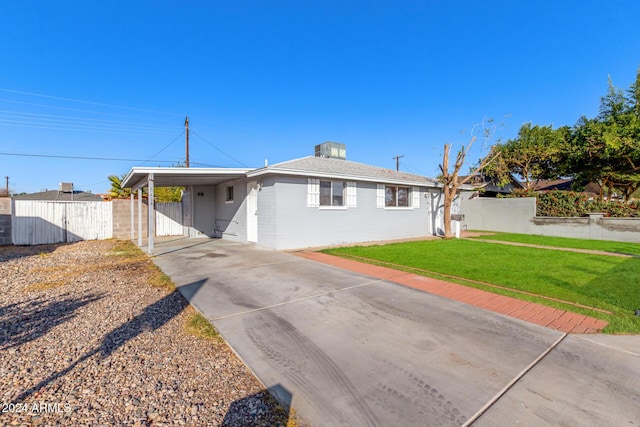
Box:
(472, 233), (640, 256)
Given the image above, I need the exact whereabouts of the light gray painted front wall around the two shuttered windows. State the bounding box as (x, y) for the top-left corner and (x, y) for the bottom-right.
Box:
(258, 176), (431, 250)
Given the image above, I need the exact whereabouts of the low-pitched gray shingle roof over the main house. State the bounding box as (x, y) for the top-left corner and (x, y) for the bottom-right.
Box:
(254, 156), (440, 186)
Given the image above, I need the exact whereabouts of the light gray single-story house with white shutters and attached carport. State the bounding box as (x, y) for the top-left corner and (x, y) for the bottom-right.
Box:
(122, 143), (450, 250)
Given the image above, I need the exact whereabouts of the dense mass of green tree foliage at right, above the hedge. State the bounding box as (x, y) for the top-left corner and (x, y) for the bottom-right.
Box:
(496, 68), (640, 200)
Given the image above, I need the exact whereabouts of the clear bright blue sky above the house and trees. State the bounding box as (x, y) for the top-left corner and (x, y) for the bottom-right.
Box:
(0, 0), (640, 193)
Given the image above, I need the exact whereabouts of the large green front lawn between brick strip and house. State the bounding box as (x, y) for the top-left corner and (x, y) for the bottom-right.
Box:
(323, 240), (640, 333)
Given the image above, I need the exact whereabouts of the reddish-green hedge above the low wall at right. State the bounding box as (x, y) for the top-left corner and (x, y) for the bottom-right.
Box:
(506, 190), (640, 218)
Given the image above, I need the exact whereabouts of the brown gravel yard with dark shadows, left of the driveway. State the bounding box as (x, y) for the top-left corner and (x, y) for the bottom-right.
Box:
(0, 240), (295, 426)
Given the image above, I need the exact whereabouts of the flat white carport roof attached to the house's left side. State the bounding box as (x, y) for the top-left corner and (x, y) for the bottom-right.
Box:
(121, 167), (251, 190)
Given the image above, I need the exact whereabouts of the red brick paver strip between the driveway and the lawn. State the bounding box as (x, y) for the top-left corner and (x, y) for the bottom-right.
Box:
(296, 252), (608, 334)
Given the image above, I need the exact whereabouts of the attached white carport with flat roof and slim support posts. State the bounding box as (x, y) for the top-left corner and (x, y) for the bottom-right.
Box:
(121, 167), (251, 255)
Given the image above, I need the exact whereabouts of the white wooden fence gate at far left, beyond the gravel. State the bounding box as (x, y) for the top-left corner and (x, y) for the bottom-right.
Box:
(11, 200), (113, 245)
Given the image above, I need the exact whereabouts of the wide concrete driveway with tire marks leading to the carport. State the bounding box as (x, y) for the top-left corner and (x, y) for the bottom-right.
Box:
(149, 239), (640, 426)
